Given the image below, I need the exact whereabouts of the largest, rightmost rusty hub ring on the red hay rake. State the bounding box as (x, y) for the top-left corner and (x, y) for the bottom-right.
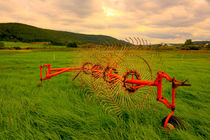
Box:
(123, 70), (141, 93)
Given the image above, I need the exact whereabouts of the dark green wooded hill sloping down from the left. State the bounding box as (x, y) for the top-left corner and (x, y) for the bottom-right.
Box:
(0, 23), (117, 45)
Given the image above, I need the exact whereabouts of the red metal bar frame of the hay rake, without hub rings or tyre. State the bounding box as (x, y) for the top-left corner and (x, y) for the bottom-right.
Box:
(37, 64), (191, 128)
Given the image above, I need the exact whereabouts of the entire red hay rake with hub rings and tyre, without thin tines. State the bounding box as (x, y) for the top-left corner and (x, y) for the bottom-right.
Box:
(39, 62), (191, 129)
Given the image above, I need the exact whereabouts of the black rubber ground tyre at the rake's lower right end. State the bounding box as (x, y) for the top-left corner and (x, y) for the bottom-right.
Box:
(161, 116), (185, 130)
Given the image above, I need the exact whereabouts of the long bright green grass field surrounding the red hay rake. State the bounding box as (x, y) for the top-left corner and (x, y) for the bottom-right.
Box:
(0, 49), (210, 140)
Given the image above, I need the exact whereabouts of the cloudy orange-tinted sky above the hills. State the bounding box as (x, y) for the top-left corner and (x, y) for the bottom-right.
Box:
(0, 0), (210, 43)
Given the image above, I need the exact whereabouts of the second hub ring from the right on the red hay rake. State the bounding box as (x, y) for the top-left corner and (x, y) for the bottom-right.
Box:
(103, 66), (118, 83)
